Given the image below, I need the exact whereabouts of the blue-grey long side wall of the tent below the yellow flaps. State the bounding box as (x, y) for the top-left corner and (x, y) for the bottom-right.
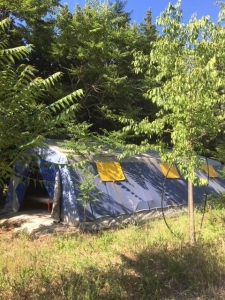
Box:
(86, 162), (217, 217)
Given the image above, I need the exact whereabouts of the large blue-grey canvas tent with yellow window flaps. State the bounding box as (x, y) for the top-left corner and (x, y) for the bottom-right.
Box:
(1, 141), (225, 228)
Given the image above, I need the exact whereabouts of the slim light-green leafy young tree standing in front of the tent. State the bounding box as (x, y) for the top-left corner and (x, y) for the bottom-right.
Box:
(119, 1), (225, 244)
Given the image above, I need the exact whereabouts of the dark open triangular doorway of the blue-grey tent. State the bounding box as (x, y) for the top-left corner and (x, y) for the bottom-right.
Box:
(20, 165), (52, 213)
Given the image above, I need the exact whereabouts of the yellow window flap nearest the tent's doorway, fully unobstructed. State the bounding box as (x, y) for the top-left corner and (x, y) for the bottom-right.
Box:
(96, 162), (125, 181)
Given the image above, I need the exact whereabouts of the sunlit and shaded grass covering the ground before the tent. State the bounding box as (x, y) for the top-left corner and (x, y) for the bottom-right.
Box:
(0, 207), (225, 300)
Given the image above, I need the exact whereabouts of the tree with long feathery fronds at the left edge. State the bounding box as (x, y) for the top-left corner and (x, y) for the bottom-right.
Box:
(0, 19), (82, 184)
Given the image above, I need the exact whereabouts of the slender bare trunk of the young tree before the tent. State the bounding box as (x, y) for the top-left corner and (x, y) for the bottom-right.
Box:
(188, 180), (195, 245)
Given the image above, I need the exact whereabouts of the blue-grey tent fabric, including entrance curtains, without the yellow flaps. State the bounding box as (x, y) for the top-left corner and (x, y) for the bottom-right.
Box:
(3, 143), (225, 223)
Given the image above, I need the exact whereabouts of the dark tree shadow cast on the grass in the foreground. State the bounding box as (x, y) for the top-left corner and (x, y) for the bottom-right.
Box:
(2, 240), (225, 300)
